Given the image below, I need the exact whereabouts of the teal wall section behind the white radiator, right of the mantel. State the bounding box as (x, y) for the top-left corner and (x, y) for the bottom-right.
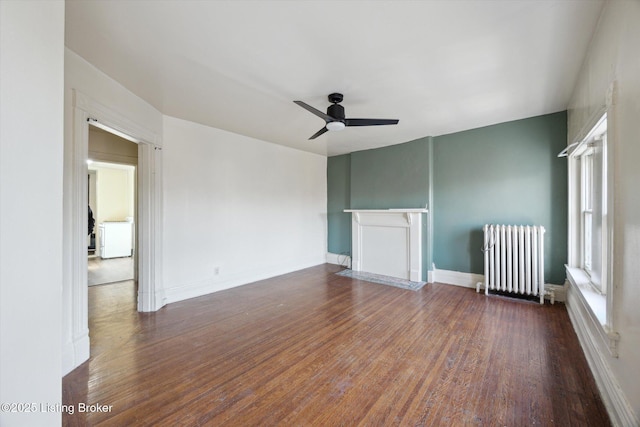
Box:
(433, 112), (567, 284)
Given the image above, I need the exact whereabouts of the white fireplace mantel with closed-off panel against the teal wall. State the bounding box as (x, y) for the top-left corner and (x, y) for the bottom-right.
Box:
(344, 209), (428, 282)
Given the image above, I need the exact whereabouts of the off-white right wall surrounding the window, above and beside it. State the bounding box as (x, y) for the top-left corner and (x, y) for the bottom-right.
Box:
(568, 0), (640, 423)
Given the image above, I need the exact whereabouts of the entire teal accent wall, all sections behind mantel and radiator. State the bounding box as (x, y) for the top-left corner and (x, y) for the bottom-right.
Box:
(327, 112), (567, 284)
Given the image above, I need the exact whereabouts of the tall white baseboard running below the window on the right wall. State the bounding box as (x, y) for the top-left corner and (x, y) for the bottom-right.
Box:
(566, 281), (640, 426)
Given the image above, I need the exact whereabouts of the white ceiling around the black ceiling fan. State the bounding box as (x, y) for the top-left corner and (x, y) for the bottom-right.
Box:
(66, 0), (603, 155)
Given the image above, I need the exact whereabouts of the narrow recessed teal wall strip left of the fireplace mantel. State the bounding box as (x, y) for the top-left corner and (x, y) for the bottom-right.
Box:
(327, 154), (351, 255)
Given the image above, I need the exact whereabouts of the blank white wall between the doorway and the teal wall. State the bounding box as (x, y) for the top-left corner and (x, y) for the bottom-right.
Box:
(163, 117), (327, 302)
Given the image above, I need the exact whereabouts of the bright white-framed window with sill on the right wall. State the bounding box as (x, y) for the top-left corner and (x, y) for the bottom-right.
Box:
(558, 82), (620, 357)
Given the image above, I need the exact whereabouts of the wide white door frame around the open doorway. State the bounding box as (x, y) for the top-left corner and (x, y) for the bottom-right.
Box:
(63, 90), (166, 367)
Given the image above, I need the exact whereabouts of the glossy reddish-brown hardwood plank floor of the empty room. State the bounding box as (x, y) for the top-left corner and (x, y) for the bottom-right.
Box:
(63, 265), (610, 426)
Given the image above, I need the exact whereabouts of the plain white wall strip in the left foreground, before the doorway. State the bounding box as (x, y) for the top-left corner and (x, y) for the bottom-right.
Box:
(0, 1), (64, 426)
